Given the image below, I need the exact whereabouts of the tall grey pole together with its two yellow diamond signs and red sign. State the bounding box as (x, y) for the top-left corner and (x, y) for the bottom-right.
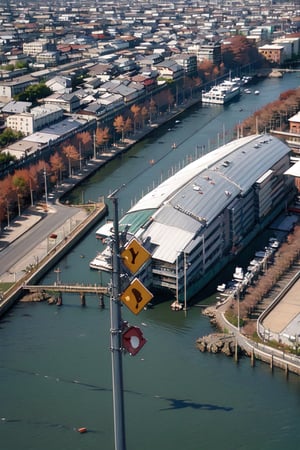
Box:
(108, 185), (153, 450)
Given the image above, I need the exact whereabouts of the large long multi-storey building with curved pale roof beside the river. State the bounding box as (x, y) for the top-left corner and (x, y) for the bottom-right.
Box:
(90, 135), (295, 303)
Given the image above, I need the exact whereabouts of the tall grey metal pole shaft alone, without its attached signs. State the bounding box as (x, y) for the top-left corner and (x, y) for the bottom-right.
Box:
(108, 189), (126, 450)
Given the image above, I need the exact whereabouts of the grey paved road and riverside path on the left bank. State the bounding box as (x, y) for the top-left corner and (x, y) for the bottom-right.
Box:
(0, 158), (106, 282)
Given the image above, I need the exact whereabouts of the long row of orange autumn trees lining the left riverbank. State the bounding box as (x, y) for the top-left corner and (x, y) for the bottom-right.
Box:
(0, 36), (268, 224)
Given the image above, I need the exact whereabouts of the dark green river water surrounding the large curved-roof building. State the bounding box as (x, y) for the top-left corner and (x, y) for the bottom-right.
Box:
(0, 73), (300, 450)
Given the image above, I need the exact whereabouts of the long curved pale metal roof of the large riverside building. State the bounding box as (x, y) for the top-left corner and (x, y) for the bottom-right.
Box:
(124, 135), (290, 263)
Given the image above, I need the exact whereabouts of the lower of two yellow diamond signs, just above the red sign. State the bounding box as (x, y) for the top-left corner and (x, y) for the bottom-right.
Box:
(120, 278), (153, 314)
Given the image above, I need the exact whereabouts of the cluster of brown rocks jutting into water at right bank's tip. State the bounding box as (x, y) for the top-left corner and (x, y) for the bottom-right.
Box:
(196, 333), (239, 356)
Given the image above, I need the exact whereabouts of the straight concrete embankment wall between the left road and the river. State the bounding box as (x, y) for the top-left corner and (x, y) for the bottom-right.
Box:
(0, 203), (107, 317)
